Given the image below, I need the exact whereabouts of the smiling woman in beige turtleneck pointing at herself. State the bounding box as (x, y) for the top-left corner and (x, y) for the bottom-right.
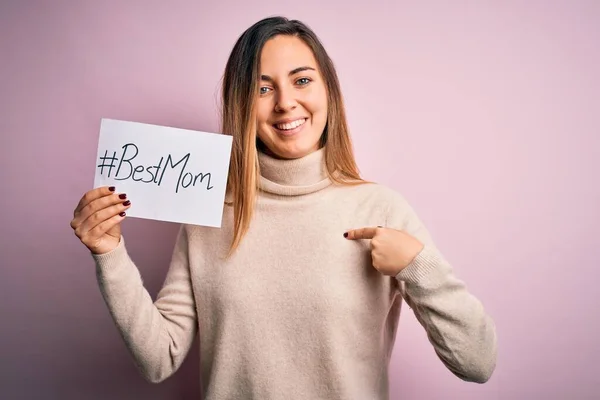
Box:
(71, 18), (496, 400)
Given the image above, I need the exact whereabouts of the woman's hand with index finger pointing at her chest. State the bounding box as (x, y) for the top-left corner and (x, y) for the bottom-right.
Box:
(344, 227), (423, 276)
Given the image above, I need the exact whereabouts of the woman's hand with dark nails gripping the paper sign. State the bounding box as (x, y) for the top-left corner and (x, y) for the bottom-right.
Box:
(71, 186), (131, 254)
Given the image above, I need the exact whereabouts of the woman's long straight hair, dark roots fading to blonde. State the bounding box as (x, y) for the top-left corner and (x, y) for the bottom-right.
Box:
(221, 17), (365, 256)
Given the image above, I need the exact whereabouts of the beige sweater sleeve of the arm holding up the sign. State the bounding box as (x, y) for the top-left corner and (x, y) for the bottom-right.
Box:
(93, 225), (197, 383)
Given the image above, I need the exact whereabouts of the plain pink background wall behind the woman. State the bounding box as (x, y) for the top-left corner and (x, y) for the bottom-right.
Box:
(0, 0), (600, 400)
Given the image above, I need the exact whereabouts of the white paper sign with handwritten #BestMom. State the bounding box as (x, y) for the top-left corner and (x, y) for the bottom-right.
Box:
(94, 119), (232, 227)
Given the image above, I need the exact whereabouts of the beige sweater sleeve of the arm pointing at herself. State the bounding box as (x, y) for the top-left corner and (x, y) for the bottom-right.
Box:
(388, 195), (497, 383)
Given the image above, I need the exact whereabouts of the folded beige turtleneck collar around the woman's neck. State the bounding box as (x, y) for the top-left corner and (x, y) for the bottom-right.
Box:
(258, 148), (331, 196)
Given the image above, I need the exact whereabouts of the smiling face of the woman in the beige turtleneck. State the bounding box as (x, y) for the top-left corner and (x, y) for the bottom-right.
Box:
(257, 35), (327, 159)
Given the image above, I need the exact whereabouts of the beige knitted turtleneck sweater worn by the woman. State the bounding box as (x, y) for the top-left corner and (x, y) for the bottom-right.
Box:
(93, 149), (496, 400)
